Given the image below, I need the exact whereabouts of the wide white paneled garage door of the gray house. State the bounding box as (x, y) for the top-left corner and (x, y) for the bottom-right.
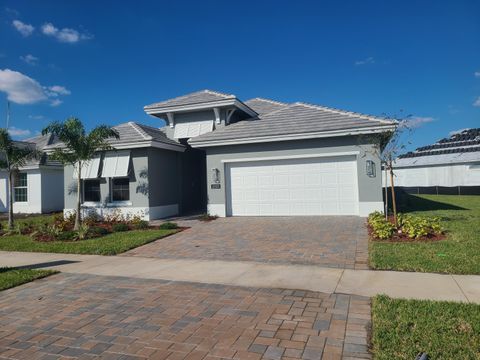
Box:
(226, 156), (358, 216)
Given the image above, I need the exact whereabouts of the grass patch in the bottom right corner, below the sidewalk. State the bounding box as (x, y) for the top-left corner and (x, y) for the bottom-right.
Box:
(372, 296), (480, 360)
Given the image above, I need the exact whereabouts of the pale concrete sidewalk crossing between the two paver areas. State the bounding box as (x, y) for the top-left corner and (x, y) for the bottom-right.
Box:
(0, 251), (480, 303)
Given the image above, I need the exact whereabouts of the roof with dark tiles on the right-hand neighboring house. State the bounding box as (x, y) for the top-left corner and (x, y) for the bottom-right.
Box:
(395, 128), (480, 167)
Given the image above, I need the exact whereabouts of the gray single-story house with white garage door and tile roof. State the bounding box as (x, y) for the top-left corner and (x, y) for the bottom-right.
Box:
(50, 90), (396, 220)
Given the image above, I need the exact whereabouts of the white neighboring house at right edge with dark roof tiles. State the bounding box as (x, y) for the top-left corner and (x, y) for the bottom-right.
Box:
(388, 128), (480, 195)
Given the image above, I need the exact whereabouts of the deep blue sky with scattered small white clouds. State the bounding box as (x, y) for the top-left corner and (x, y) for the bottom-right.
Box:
(0, 0), (480, 148)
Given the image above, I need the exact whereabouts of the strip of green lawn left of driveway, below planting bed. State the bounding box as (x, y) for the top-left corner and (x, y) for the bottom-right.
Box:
(0, 230), (178, 255)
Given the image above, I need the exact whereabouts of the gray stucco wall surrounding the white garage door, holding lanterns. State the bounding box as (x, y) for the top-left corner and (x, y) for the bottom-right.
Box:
(206, 136), (382, 214)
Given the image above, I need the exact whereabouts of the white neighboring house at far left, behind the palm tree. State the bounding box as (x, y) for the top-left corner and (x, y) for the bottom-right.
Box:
(0, 134), (64, 214)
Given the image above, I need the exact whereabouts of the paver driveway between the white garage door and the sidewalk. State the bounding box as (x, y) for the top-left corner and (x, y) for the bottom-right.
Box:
(125, 216), (368, 269)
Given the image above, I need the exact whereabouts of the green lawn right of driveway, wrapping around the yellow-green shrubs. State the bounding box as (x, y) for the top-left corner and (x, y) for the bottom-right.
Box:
(369, 195), (480, 274)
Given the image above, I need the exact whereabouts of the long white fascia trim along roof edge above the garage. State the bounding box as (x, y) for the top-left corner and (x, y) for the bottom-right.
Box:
(189, 125), (396, 148)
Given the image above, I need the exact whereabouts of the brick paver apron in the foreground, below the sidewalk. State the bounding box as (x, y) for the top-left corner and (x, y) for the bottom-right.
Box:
(0, 274), (371, 360)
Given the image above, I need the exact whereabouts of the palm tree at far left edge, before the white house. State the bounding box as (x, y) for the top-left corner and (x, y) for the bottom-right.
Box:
(0, 128), (40, 230)
